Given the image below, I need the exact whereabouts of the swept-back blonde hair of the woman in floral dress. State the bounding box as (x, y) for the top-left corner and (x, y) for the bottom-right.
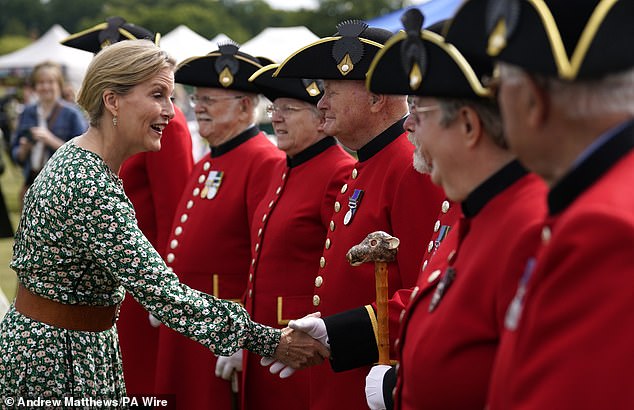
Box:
(77, 40), (173, 127)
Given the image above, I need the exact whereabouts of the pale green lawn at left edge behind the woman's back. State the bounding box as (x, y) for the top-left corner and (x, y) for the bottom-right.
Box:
(0, 153), (24, 301)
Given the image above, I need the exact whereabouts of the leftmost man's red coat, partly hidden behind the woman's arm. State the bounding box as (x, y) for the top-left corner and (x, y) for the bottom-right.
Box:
(117, 107), (194, 395)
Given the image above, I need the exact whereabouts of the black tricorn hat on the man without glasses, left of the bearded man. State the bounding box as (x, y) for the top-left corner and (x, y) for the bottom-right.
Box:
(273, 20), (392, 80)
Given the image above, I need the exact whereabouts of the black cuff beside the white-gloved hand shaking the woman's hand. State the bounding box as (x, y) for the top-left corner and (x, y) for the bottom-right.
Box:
(323, 307), (379, 372)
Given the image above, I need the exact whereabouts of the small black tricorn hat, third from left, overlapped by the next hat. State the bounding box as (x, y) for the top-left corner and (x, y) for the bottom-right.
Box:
(249, 64), (324, 105)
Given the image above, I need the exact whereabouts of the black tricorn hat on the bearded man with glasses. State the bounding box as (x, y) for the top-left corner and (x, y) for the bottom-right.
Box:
(366, 8), (493, 99)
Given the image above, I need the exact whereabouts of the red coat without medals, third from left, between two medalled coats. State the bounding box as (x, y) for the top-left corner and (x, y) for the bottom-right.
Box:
(242, 137), (354, 410)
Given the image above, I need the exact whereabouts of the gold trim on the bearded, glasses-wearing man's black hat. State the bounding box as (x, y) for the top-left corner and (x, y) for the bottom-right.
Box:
(365, 30), (493, 97)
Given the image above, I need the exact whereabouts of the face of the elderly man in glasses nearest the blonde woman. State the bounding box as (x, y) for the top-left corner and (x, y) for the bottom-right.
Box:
(194, 87), (246, 147)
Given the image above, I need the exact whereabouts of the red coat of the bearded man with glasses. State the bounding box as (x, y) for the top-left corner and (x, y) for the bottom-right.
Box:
(395, 162), (546, 409)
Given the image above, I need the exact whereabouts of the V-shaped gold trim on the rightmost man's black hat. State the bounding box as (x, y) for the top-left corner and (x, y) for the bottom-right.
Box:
(528, 0), (618, 80)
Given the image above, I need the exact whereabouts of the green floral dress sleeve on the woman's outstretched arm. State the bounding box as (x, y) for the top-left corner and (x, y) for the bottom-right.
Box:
(75, 173), (279, 356)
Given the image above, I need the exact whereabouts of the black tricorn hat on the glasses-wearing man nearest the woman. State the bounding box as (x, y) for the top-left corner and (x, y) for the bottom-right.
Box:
(174, 43), (262, 94)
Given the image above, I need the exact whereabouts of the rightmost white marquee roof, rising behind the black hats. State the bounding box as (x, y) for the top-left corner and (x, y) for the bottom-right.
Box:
(240, 26), (319, 63)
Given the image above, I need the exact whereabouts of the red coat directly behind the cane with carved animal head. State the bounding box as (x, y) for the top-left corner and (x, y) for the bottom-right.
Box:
(308, 121), (443, 410)
